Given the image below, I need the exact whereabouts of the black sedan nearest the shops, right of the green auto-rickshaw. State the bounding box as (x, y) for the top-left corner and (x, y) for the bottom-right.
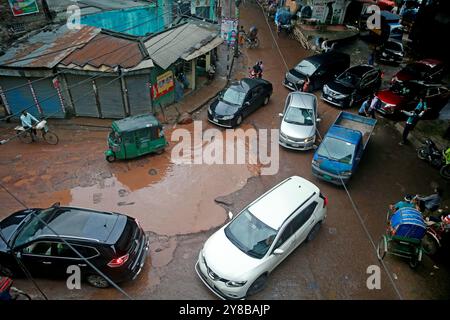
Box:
(208, 78), (273, 128)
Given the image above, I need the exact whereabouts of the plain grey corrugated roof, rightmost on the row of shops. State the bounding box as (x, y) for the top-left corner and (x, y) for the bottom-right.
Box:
(145, 23), (219, 69)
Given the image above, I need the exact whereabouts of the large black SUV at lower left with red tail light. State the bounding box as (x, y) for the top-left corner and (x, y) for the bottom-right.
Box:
(0, 205), (149, 288)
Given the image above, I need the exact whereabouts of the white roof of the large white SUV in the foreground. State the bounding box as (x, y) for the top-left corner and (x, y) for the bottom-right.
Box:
(248, 176), (320, 230)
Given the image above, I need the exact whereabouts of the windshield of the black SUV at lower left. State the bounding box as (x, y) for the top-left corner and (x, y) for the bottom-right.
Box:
(14, 208), (58, 247)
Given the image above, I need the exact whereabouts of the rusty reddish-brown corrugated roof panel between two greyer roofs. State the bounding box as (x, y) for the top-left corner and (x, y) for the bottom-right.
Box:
(61, 33), (145, 68)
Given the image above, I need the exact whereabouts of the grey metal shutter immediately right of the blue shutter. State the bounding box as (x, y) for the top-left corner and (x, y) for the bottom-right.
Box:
(66, 74), (100, 118)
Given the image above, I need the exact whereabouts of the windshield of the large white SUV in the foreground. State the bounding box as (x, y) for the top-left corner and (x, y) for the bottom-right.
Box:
(225, 210), (277, 259)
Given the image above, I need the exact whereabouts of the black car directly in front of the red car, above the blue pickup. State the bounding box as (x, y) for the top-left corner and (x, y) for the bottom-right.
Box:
(322, 64), (381, 108)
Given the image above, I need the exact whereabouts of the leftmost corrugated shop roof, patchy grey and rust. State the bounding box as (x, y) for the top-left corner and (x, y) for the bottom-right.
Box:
(0, 25), (101, 68)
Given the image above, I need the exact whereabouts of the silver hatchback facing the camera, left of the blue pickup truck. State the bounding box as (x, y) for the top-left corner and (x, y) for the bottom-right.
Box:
(279, 91), (321, 150)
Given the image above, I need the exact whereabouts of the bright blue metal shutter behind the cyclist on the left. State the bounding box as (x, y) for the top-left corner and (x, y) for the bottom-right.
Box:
(30, 79), (64, 118)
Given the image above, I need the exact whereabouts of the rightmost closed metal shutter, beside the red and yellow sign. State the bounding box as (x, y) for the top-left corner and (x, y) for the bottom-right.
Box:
(126, 75), (152, 115)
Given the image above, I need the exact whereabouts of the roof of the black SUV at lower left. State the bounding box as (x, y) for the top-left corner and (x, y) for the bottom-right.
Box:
(35, 207), (126, 243)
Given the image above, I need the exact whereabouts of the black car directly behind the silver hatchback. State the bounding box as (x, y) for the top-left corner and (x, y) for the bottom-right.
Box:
(283, 51), (350, 91)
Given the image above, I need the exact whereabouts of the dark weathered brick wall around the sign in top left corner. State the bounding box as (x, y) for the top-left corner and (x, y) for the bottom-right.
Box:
(0, 0), (47, 51)
